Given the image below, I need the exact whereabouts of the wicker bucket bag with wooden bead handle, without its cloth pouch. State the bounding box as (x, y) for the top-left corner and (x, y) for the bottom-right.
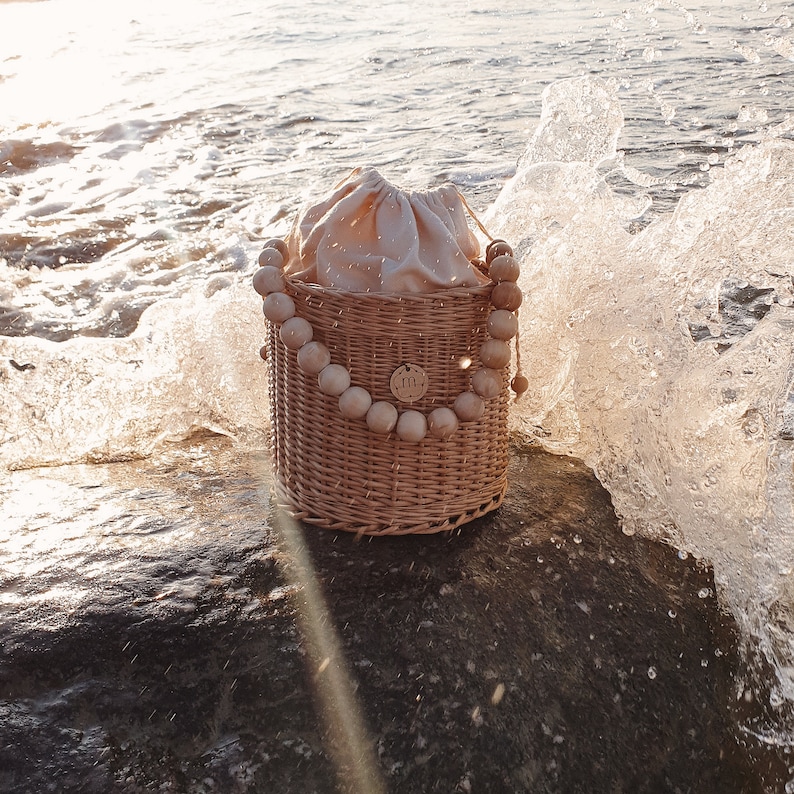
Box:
(254, 169), (523, 535)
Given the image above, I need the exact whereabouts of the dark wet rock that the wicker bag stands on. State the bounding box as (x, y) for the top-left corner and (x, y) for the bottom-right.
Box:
(0, 441), (783, 794)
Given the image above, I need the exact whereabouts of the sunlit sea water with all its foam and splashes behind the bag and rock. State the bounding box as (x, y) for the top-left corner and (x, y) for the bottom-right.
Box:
(0, 0), (794, 745)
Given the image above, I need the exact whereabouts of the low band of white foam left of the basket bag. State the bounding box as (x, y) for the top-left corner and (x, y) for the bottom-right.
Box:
(0, 278), (268, 468)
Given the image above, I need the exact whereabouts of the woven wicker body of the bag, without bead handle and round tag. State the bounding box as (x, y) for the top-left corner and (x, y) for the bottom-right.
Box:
(267, 280), (508, 535)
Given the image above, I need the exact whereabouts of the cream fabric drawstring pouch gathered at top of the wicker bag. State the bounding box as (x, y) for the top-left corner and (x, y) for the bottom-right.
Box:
(287, 168), (487, 292)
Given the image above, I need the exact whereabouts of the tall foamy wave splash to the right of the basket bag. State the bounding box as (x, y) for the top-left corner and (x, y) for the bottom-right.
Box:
(486, 77), (794, 743)
